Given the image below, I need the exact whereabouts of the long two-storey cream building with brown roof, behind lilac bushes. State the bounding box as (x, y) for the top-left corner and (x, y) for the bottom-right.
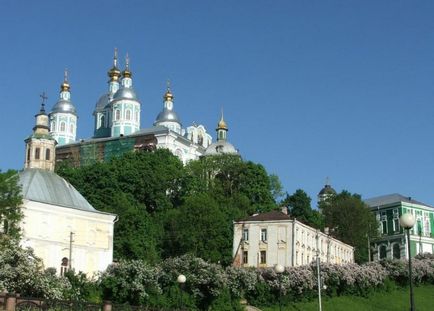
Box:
(233, 211), (354, 268)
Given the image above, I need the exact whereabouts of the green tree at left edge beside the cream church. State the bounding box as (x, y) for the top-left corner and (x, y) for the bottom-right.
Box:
(0, 170), (23, 245)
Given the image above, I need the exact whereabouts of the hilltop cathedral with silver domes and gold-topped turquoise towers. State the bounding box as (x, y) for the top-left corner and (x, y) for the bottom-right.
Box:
(49, 50), (239, 166)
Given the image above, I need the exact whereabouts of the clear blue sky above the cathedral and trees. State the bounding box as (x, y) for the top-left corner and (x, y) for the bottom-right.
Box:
(0, 0), (434, 205)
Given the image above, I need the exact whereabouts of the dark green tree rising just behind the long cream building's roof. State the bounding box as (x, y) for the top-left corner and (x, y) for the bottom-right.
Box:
(282, 189), (324, 229)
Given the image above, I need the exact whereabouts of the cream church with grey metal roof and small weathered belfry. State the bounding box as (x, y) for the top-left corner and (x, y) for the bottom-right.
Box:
(19, 104), (116, 276)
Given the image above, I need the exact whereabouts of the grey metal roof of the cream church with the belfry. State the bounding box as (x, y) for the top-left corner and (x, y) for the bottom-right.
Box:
(18, 169), (97, 212)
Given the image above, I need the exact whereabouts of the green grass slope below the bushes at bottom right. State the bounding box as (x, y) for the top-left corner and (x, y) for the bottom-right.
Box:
(261, 285), (434, 311)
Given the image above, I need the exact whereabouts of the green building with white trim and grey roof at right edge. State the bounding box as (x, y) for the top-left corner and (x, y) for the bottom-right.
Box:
(365, 193), (434, 260)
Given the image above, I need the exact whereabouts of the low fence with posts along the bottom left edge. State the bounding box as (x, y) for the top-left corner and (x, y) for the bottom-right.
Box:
(0, 293), (182, 311)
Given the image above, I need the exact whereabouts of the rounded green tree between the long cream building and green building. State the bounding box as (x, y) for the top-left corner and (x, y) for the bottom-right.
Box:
(320, 191), (378, 263)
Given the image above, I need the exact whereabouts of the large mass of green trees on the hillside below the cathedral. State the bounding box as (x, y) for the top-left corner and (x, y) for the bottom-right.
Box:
(58, 149), (281, 265)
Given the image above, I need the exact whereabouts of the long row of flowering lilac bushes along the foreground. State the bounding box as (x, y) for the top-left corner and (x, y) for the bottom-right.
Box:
(0, 245), (434, 310)
